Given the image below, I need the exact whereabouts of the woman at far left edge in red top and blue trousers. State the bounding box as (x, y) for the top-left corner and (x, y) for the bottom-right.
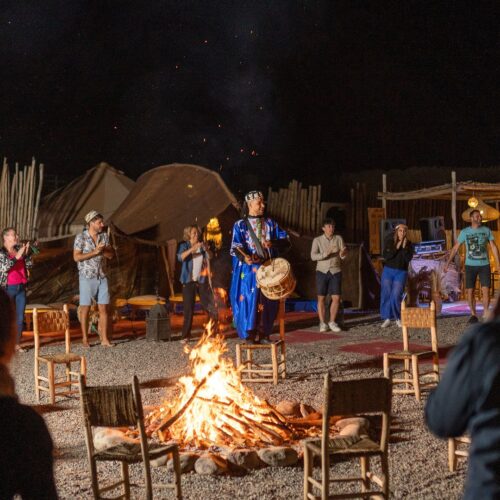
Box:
(0, 227), (33, 352)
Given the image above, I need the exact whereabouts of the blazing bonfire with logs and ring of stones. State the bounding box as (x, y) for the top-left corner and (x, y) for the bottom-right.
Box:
(99, 324), (363, 474)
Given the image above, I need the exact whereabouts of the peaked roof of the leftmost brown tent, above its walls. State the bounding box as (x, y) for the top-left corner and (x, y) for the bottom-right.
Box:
(38, 163), (135, 239)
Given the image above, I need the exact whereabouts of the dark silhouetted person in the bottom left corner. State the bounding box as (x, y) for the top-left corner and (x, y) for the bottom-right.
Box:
(0, 290), (57, 500)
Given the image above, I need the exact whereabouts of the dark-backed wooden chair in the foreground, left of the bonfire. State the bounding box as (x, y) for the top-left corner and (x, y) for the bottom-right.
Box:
(80, 377), (182, 500)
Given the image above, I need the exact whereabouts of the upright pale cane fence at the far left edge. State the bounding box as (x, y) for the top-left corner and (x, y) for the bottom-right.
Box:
(0, 158), (44, 240)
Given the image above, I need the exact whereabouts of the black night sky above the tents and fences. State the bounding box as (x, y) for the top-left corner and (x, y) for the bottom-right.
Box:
(0, 0), (500, 193)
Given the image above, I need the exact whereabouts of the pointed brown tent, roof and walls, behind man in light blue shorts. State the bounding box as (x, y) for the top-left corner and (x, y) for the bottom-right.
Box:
(28, 163), (145, 304)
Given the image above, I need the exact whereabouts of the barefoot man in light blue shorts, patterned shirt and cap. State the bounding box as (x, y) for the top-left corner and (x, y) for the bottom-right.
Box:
(73, 210), (115, 347)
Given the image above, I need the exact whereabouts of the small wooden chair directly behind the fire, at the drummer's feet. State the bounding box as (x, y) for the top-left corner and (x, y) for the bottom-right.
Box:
(236, 300), (286, 385)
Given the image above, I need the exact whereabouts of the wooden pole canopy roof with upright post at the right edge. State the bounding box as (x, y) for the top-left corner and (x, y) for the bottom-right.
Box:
(377, 172), (500, 241)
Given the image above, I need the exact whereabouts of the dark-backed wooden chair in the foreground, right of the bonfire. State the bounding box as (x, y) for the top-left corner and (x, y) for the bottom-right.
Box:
(302, 374), (391, 500)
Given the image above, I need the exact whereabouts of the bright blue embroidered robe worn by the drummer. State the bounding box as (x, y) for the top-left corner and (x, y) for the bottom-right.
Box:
(229, 217), (288, 339)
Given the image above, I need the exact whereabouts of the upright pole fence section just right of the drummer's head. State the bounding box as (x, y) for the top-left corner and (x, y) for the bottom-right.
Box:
(267, 180), (322, 234)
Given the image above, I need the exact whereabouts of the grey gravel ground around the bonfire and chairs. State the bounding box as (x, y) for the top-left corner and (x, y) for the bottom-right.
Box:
(8, 317), (467, 500)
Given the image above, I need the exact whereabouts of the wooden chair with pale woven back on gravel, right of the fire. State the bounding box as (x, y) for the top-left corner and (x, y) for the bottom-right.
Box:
(384, 301), (439, 401)
